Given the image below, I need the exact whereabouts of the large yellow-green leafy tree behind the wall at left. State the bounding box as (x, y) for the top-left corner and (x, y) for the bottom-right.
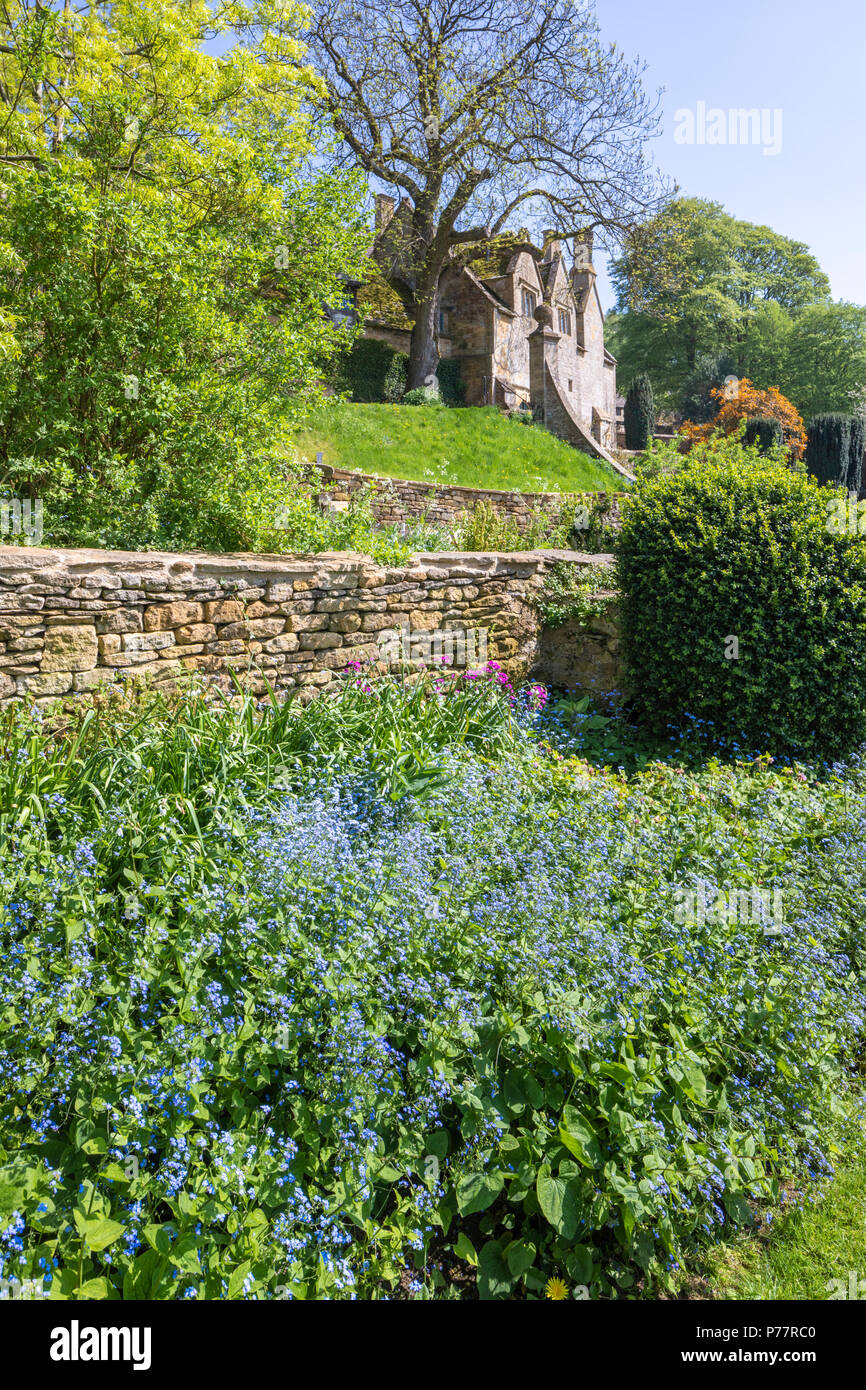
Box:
(0, 0), (364, 549)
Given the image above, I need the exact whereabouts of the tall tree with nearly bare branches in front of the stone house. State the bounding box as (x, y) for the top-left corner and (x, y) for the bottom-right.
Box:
(309, 0), (664, 386)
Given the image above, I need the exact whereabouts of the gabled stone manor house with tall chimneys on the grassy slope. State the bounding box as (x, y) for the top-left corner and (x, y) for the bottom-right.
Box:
(332, 195), (617, 457)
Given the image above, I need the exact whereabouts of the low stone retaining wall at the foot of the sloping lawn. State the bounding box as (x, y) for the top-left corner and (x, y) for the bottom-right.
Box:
(316, 463), (626, 531)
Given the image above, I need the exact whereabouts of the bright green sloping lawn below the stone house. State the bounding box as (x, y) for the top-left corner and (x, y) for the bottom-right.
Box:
(291, 403), (626, 492)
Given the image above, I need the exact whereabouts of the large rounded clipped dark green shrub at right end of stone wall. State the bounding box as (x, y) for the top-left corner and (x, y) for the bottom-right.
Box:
(617, 455), (866, 756)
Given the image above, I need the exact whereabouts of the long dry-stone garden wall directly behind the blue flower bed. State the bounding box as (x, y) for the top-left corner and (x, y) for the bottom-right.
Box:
(0, 546), (620, 705)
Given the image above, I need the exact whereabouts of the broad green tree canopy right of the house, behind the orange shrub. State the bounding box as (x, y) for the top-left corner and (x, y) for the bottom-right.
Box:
(607, 199), (866, 418)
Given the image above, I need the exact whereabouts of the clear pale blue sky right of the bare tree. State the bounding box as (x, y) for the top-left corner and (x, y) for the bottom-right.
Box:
(595, 0), (866, 310)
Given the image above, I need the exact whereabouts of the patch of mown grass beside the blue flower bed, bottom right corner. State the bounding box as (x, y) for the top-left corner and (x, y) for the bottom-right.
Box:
(692, 1140), (866, 1300)
